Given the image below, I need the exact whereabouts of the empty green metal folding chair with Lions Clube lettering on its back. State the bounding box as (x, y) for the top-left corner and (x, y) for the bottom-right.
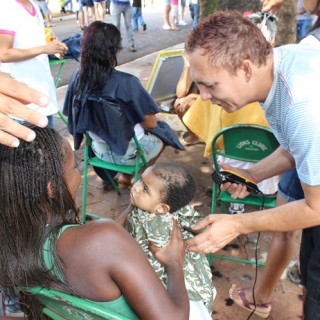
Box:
(208, 124), (279, 265)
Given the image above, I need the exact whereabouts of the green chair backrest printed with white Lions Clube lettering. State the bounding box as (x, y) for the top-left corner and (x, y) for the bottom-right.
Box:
(212, 124), (279, 169)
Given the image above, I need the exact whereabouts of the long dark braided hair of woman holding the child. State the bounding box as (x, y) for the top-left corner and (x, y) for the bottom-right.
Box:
(0, 125), (78, 319)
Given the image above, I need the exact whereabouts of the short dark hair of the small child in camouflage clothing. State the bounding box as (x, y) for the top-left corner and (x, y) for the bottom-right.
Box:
(152, 163), (197, 212)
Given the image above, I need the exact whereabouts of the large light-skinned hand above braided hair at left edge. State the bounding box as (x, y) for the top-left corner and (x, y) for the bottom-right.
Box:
(0, 73), (49, 147)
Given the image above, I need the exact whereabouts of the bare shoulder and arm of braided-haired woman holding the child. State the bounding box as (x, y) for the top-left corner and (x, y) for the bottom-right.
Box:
(65, 219), (189, 320)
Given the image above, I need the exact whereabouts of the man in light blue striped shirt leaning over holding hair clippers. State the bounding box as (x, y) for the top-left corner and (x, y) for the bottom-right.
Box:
(185, 12), (320, 319)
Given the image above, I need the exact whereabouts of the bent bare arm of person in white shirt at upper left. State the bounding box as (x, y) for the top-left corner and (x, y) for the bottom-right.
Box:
(0, 34), (68, 62)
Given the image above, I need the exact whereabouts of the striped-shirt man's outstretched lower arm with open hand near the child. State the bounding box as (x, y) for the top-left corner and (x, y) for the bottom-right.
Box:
(186, 179), (320, 253)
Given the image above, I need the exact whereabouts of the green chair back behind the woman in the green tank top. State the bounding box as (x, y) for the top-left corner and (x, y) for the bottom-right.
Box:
(25, 287), (130, 320)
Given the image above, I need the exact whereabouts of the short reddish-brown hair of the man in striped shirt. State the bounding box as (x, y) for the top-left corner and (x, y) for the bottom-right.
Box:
(185, 11), (272, 74)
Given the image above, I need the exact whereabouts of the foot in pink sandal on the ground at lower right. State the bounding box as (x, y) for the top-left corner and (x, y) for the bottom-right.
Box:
(229, 284), (271, 319)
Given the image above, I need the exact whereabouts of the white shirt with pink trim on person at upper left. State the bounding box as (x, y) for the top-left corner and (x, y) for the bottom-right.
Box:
(0, 0), (58, 115)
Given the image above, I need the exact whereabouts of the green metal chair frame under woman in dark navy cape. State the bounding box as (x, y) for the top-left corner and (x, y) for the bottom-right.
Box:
(82, 134), (148, 222)
